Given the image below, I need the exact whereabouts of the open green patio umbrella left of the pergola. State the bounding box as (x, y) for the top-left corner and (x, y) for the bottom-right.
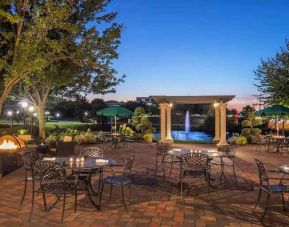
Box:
(96, 106), (133, 133)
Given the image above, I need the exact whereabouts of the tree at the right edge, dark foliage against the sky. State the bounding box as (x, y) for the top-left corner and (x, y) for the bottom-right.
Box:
(255, 41), (289, 105)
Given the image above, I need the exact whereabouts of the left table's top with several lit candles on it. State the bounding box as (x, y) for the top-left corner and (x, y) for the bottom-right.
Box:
(43, 157), (116, 169)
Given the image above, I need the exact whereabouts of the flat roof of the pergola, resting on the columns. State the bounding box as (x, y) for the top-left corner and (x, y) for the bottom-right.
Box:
(150, 95), (235, 104)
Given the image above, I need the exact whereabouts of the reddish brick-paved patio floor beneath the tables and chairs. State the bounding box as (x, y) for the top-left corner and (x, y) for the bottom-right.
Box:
(0, 144), (289, 227)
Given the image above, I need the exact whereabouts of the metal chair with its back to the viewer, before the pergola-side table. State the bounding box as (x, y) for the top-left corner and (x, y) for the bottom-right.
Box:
(180, 153), (211, 196)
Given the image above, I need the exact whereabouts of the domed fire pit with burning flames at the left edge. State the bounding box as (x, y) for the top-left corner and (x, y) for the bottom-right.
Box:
(0, 135), (25, 177)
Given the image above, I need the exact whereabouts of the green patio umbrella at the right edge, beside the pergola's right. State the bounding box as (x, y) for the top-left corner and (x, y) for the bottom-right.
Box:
(255, 105), (289, 134)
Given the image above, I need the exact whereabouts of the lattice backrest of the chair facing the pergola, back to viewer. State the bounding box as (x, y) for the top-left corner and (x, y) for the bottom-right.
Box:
(182, 153), (208, 171)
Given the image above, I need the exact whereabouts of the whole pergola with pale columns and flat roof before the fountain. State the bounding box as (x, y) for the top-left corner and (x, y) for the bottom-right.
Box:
(150, 95), (235, 147)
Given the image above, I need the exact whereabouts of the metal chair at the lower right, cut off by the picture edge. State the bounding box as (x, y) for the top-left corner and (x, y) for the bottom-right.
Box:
(254, 159), (289, 220)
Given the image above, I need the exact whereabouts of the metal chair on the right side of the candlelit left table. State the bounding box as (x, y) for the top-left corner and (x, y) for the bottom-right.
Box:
(100, 155), (135, 211)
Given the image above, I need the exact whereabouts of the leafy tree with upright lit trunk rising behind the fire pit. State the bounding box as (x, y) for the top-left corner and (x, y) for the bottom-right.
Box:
(9, 0), (123, 138)
